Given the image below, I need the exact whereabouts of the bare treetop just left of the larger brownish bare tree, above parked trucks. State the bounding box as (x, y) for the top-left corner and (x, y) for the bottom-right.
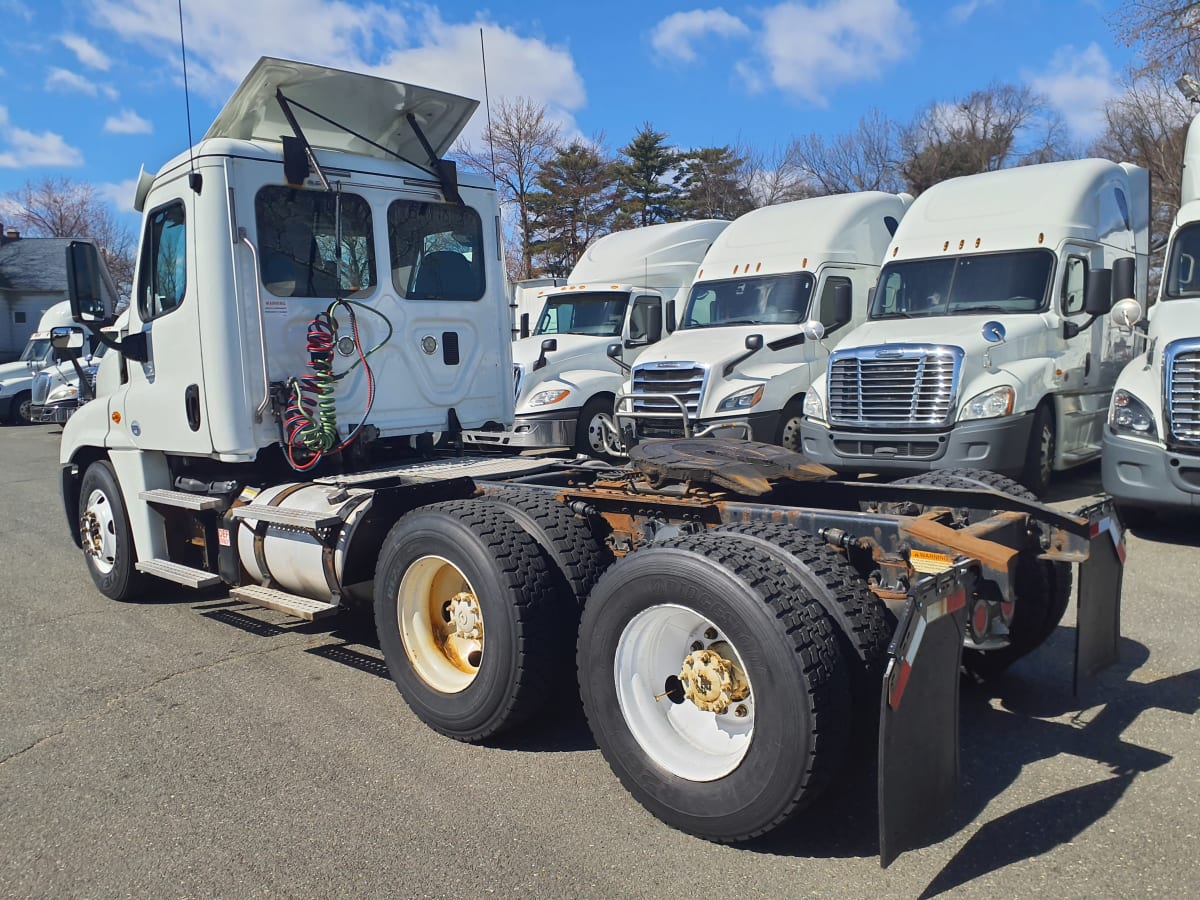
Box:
(788, 109), (902, 194)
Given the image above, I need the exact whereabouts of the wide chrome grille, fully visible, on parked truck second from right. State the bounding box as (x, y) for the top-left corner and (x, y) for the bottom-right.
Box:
(828, 344), (962, 427)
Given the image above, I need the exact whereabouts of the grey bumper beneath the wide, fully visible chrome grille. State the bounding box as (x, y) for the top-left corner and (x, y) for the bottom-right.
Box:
(800, 415), (1033, 475)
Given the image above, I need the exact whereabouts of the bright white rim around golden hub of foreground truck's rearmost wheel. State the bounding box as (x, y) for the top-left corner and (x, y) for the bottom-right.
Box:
(613, 604), (755, 781)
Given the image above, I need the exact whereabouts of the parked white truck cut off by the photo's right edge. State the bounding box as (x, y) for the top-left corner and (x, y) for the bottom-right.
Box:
(1100, 116), (1200, 516)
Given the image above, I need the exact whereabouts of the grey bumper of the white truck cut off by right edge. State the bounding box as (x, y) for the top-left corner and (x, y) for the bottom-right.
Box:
(1100, 428), (1200, 509)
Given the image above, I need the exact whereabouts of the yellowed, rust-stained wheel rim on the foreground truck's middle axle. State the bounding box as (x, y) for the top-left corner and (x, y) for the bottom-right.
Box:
(396, 556), (484, 694)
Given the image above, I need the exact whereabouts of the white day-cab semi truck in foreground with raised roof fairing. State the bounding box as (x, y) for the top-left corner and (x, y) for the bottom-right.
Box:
(53, 59), (1123, 863)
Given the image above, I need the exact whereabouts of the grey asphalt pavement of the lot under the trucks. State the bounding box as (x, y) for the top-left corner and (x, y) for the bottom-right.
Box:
(0, 426), (1200, 900)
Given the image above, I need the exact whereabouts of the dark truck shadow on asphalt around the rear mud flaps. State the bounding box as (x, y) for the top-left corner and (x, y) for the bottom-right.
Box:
(748, 628), (1200, 898)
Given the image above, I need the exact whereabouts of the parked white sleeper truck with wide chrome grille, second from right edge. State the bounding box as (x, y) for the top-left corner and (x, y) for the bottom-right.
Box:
(802, 160), (1150, 496)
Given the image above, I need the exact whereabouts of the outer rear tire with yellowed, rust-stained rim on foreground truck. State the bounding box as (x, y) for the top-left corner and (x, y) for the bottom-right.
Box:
(374, 499), (561, 740)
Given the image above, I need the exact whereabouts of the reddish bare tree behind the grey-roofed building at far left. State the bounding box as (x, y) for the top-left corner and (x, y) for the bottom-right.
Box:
(7, 178), (134, 302)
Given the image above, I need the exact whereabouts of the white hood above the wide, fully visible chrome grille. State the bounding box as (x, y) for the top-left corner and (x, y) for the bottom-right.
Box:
(835, 314), (1052, 362)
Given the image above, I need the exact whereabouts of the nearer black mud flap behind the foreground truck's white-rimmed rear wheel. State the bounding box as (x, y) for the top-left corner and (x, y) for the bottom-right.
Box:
(878, 563), (970, 868)
